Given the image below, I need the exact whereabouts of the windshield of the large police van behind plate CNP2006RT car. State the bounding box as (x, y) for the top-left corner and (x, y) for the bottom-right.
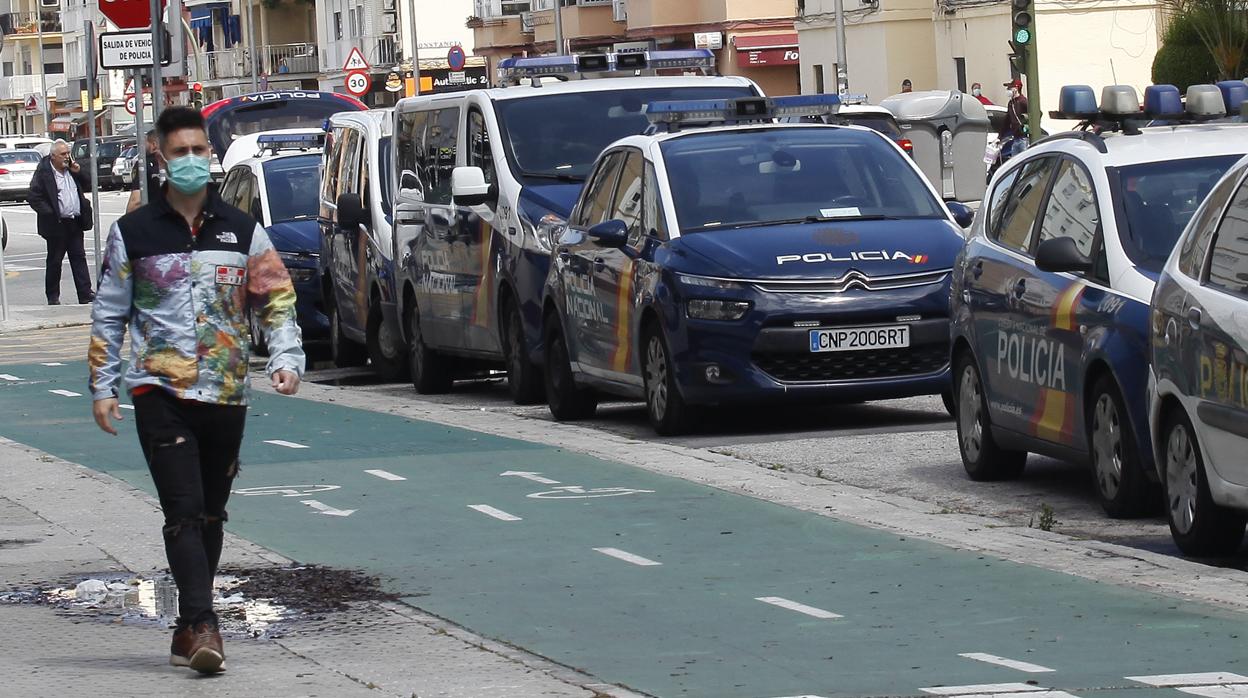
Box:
(494, 85), (755, 181)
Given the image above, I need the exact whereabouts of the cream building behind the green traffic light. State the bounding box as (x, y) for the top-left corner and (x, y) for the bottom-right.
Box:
(796, 0), (1161, 127)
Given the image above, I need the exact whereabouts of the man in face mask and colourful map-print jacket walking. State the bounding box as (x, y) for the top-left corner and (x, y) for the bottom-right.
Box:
(87, 107), (305, 673)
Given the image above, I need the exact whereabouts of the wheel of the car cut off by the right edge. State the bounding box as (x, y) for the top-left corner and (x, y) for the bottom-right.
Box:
(1162, 410), (1248, 556)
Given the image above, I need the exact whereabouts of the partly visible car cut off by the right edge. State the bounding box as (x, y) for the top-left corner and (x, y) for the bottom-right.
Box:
(1148, 157), (1248, 556)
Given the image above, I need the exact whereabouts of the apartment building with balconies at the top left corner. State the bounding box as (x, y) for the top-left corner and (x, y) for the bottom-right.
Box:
(0, 0), (65, 134)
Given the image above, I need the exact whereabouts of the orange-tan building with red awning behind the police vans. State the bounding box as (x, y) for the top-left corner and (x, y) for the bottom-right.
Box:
(468, 0), (800, 95)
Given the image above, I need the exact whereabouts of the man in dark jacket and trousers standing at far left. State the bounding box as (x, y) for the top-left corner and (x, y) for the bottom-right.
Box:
(26, 141), (95, 306)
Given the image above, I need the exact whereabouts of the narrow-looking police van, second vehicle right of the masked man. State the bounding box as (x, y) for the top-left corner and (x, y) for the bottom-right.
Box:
(317, 109), (396, 381)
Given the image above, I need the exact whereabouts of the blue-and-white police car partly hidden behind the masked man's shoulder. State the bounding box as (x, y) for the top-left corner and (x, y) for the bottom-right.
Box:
(221, 129), (329, 351)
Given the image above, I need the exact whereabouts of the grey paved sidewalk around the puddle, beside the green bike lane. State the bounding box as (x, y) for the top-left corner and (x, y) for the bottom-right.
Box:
(0, 438), (633, 698)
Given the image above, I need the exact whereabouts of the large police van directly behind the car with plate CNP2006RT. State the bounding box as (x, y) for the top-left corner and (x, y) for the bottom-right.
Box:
(393, 50), (760, 403)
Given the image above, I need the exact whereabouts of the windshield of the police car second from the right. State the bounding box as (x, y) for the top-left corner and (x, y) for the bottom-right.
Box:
(1114, 155), (1241, 273)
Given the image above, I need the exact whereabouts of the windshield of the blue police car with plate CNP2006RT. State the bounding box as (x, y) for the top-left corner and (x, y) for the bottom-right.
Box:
(661, 126), (947, 232)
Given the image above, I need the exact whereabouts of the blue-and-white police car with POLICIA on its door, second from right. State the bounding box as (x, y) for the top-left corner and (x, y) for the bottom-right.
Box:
(951, 85), (1248, 517)
